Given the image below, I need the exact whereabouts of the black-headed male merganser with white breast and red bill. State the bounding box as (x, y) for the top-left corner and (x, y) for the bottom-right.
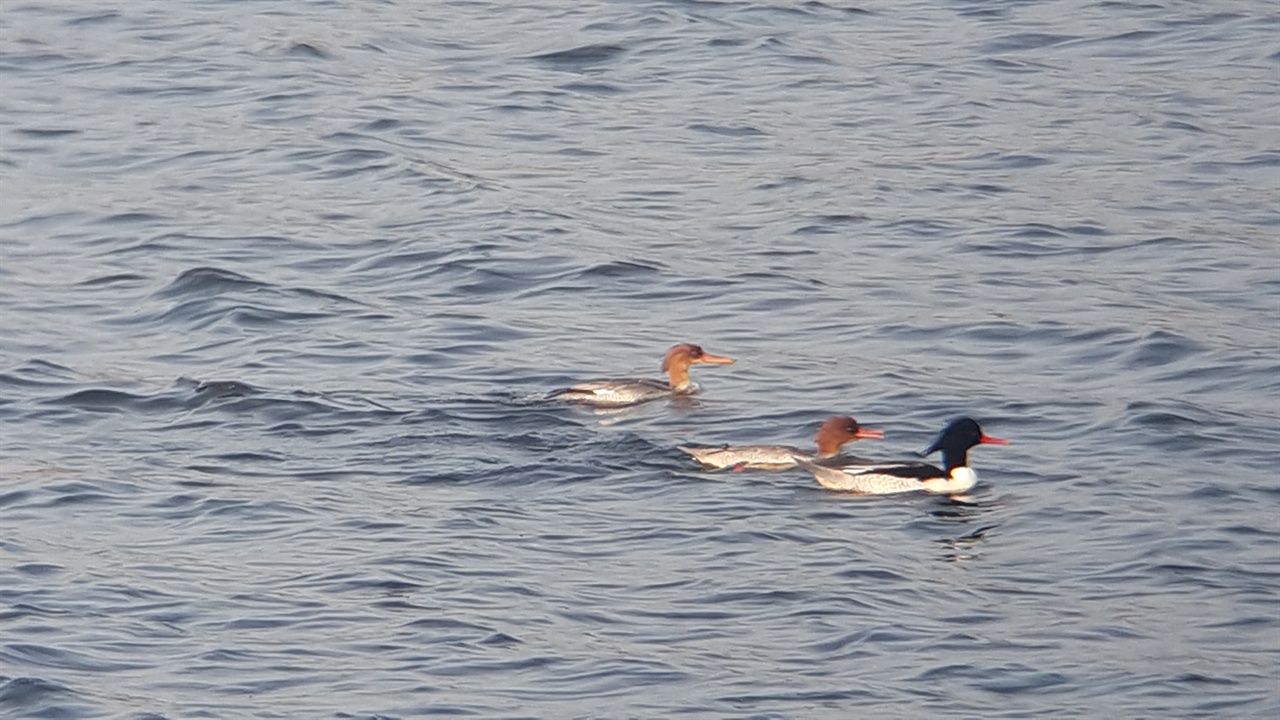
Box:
(796, 418), (1009, 496)
